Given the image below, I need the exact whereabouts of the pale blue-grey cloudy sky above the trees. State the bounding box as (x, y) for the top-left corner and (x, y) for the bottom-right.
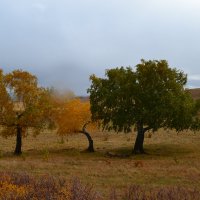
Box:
(0, 0), (200, 95)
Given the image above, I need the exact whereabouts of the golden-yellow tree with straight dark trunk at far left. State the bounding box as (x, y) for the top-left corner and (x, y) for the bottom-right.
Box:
(0, 70), (51, 155)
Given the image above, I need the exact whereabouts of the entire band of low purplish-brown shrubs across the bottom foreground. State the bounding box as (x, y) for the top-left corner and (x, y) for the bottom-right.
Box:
(0, 173), (200, 200)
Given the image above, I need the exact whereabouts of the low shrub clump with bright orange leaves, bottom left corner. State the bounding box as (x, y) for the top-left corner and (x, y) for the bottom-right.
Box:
(0, 173), (101, 200)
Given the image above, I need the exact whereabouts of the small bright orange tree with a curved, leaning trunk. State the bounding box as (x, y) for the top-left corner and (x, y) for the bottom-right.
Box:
(55, 99), (96, 152)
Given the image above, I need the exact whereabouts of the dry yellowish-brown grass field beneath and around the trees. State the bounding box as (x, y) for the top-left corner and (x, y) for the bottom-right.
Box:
(0, 130), (200, 197)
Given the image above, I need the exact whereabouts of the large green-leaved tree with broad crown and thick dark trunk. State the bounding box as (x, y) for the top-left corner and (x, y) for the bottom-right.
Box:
(88, 60), (196, 153)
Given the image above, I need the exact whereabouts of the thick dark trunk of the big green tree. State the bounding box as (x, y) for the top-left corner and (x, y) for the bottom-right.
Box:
(133, 122), (145, 154)
